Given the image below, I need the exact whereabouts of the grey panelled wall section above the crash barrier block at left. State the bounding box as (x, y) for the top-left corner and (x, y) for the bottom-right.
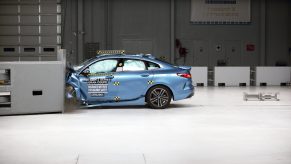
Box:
(0, 0), (62, 61)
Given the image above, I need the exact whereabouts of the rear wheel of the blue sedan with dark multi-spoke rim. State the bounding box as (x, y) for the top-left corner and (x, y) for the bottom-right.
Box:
(146, 85), (172, 109)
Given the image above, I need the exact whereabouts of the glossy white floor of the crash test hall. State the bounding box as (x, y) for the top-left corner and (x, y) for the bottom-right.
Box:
(0, 87), (291, 164)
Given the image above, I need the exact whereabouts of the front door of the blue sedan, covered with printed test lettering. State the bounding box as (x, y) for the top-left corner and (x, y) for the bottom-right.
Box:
(79, 59), (119, 102)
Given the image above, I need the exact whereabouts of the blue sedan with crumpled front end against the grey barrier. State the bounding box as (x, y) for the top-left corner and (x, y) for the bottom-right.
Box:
(66, 50), (194, 109)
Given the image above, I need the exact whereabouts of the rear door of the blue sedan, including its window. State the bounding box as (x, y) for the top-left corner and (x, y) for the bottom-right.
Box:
(113, 58), (153, 101)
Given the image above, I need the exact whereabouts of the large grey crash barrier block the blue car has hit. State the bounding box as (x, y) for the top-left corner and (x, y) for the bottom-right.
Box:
(0, 50), (66, 115)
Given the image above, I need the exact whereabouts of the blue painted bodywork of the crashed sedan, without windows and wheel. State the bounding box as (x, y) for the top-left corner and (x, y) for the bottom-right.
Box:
(66, 54), (194, 106)
